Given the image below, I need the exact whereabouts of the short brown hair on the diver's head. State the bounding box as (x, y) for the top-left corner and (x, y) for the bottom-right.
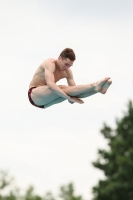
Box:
(60, 48), (76, 61)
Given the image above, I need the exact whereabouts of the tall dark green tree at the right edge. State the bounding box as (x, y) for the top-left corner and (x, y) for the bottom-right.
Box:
(93, 101), (133, 200)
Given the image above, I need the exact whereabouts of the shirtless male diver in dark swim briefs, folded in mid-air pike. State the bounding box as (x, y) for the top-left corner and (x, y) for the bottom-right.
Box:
(28, 48), (112, 108)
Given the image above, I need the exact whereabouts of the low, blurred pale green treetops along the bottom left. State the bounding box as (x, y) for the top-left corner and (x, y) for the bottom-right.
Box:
(0, 171), (82, 200)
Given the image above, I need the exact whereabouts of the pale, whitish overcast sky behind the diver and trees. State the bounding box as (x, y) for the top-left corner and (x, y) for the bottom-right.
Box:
(0, 0), (133, 200)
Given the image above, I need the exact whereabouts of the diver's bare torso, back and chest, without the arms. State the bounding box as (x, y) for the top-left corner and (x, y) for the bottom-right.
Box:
(29, 58), (67, 88)
